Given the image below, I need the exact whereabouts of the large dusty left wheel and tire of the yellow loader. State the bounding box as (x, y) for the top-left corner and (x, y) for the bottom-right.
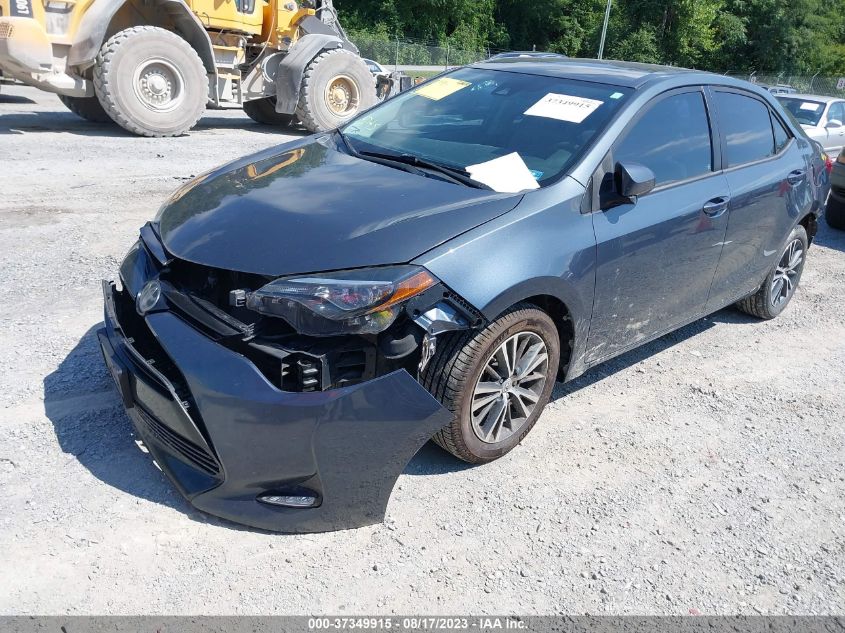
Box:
(94, 26), (208, 137)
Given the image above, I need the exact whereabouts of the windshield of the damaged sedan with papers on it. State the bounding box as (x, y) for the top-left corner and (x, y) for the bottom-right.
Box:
(343, 68), (630, 191)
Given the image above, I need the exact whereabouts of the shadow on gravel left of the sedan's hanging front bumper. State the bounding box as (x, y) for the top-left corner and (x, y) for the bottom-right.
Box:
(43, 324), (270, 534)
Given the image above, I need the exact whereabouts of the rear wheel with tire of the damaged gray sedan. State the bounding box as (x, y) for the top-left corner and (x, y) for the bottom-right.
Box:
(736, 225), (808, 319)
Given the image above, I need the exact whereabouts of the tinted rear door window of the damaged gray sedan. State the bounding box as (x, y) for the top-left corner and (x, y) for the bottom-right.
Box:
(714, 92), (775, 167)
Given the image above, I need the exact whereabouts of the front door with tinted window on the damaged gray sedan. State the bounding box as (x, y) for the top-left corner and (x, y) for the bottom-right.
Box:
(587, 88), (729, 362)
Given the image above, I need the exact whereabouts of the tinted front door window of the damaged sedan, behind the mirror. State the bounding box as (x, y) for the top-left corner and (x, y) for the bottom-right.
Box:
(613, 92), (713, 185)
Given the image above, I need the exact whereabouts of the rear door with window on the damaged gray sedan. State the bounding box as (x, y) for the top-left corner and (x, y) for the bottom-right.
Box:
(708, 88), (814, 311)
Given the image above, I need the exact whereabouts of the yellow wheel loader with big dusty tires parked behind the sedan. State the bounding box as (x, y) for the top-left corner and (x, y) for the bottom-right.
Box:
(0, 0), (376, 137)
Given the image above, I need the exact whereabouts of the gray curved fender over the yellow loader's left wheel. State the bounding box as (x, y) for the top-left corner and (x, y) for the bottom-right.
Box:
(68, 0), (217, 75)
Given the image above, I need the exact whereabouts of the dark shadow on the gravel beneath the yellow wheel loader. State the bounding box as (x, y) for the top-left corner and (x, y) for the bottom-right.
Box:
(0, 110), (310, 138)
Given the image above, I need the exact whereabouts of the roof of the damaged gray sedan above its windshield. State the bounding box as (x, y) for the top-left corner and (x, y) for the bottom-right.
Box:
(472, 57), (732, 88)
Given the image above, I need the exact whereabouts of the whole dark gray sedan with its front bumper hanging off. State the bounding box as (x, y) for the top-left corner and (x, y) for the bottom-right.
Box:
(99, 58), (827, 532)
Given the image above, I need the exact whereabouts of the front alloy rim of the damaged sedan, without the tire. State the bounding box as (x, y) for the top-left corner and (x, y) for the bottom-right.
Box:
(470, 332), (549, 444)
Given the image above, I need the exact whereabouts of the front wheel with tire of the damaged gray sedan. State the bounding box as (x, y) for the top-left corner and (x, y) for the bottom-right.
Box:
(421, 304), (560, 464)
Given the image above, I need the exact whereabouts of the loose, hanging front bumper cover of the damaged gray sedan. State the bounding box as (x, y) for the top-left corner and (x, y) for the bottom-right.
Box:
(98, 282), (450, 533)
